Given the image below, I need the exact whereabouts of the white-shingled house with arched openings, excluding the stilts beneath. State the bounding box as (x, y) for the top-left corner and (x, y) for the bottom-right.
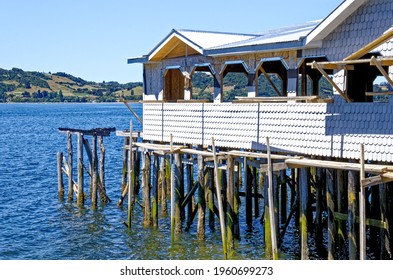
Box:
(128, 0), (393, 162)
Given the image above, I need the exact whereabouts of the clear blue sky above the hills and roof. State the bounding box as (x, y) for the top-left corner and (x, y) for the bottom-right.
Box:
(0, 0), (342, 83)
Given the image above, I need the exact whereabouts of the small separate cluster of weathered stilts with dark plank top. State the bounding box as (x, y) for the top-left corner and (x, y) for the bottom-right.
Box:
(57, 128), (116, 207)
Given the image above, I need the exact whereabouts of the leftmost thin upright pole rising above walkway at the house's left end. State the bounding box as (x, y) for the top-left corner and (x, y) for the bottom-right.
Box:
(129, 121), (135, 228)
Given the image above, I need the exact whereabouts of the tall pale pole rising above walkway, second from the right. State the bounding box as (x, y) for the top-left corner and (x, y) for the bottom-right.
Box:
(266, 137), (278, 260)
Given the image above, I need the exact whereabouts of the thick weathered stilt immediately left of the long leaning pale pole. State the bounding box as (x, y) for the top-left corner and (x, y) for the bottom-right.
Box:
(197, 155), (207, 240)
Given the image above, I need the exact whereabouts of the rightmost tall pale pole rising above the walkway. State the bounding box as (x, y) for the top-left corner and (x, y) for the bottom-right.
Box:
(359, 144), (366, 260)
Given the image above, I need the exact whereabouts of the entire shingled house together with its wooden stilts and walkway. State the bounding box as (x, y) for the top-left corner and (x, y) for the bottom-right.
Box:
(119, 0), (393, 259)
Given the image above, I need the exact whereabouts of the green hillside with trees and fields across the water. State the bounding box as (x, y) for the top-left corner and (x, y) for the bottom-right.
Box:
(0, 68), (143, 102)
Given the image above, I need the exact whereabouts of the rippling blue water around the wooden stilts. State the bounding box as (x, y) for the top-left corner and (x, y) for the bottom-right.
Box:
(0, 104), (297, 260)
